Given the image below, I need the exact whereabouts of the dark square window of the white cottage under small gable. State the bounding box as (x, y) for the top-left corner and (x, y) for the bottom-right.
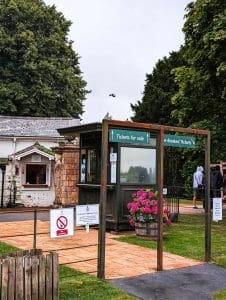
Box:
(26, 164), (47, 185)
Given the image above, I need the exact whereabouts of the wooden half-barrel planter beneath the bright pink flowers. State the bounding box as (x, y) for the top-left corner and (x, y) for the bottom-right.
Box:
(135, 222), (158, 241)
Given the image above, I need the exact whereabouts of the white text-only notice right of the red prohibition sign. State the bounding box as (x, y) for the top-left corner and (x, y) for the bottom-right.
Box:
(75, 204), (99, 226)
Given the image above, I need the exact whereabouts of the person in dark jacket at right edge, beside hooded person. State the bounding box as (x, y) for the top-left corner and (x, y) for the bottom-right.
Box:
(210, 165), (223, 198)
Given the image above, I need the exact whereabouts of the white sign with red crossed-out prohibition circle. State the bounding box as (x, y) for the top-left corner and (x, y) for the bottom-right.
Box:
(50, 207), (74, 238)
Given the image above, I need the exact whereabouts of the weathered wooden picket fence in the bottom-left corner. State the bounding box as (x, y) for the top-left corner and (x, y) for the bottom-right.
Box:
(0, 249), (59, 300)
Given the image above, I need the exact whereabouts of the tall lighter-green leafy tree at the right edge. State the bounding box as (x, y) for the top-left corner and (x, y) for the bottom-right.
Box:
(173, 0), (226, 161)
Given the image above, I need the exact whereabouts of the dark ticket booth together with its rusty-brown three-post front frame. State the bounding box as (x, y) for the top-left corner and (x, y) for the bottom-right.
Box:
(58, 119), (211, 278)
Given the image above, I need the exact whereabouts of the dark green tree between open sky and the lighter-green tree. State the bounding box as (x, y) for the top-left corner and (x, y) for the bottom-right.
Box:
(131, 49), (184, 125)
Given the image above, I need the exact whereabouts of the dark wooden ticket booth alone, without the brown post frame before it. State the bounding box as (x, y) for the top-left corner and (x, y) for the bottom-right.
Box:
(59, 122), (157, 231)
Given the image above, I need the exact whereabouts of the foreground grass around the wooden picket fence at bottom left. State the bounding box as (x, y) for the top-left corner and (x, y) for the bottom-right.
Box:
(0, 242), (136, 300)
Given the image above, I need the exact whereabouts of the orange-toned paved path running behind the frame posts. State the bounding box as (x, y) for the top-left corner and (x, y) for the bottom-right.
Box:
(0, 220), (203, 279)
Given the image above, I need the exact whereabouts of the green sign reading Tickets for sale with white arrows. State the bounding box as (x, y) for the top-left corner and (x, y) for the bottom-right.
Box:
(109, 129), (150, 144)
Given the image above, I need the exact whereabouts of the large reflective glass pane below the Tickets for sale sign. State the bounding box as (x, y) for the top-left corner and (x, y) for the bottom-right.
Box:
(120, 147), (156, 184)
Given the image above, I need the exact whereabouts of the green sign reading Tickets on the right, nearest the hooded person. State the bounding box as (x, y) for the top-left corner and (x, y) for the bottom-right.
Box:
(164, 134), (195, 148)
